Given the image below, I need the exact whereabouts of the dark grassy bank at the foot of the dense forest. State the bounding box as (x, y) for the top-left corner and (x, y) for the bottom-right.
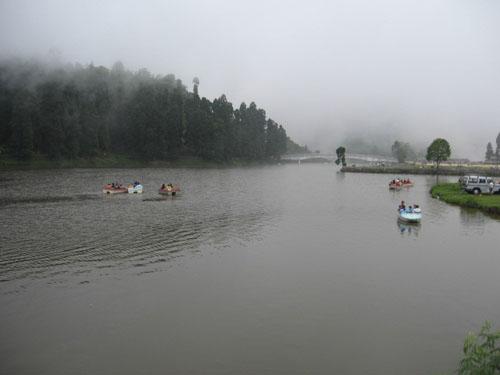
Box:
(0, 154), (273, 170)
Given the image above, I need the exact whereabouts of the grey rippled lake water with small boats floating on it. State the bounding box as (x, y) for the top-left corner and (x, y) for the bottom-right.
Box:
(0, 165), (500, 375)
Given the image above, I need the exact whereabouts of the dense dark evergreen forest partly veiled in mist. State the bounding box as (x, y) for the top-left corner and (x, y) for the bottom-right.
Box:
(0, 59), (290, 161)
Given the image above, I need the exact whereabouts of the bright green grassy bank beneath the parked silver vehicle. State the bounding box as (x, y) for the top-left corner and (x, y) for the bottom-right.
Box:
(431, 183), (500, 215)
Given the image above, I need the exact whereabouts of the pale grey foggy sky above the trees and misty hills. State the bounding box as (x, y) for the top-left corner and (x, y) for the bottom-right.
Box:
(0, 0), (500, 159)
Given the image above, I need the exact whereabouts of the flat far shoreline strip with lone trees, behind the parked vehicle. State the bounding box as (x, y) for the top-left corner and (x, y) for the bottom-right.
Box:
(341, 164), (500, 177)
